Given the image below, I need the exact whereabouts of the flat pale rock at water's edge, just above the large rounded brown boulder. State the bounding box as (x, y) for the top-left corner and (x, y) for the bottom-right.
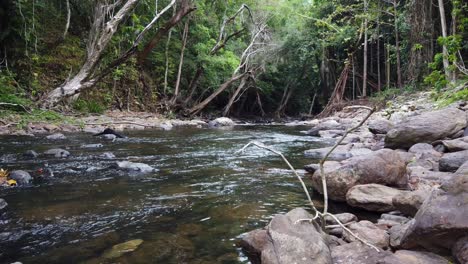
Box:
(304, 144), (372, 161)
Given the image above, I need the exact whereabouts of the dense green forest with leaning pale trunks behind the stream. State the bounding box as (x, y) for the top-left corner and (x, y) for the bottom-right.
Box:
(0, 0), (468, 117)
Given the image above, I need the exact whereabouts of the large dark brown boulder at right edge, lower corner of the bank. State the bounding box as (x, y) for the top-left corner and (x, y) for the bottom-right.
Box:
(402, 187), (468, 253)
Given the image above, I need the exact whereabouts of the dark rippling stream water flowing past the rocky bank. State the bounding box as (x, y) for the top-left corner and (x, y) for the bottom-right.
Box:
(0, 126), (362, 264)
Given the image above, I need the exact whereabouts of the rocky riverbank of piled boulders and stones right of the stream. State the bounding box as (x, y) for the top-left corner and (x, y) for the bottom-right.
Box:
(240, 94), (468, 264)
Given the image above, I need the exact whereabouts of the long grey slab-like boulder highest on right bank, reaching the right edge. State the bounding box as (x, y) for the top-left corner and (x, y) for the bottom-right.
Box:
(385, 108), (467, 149)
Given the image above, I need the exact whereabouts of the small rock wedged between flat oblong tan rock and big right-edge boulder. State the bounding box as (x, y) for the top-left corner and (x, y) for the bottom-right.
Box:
(392, 190), (430, 216)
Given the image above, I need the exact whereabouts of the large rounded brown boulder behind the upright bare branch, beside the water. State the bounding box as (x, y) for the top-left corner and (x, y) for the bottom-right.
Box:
(312, 149), (408, 201)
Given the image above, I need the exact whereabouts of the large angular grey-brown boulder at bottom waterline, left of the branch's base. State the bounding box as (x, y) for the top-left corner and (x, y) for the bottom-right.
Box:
(240, 208), (332, 264)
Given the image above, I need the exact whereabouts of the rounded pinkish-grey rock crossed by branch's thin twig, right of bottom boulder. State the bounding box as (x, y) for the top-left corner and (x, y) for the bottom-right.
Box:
(343, 221), (390, 249)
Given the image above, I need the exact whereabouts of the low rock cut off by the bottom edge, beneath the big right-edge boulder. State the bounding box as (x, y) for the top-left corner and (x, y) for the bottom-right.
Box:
(378, 250), (450, 264)
